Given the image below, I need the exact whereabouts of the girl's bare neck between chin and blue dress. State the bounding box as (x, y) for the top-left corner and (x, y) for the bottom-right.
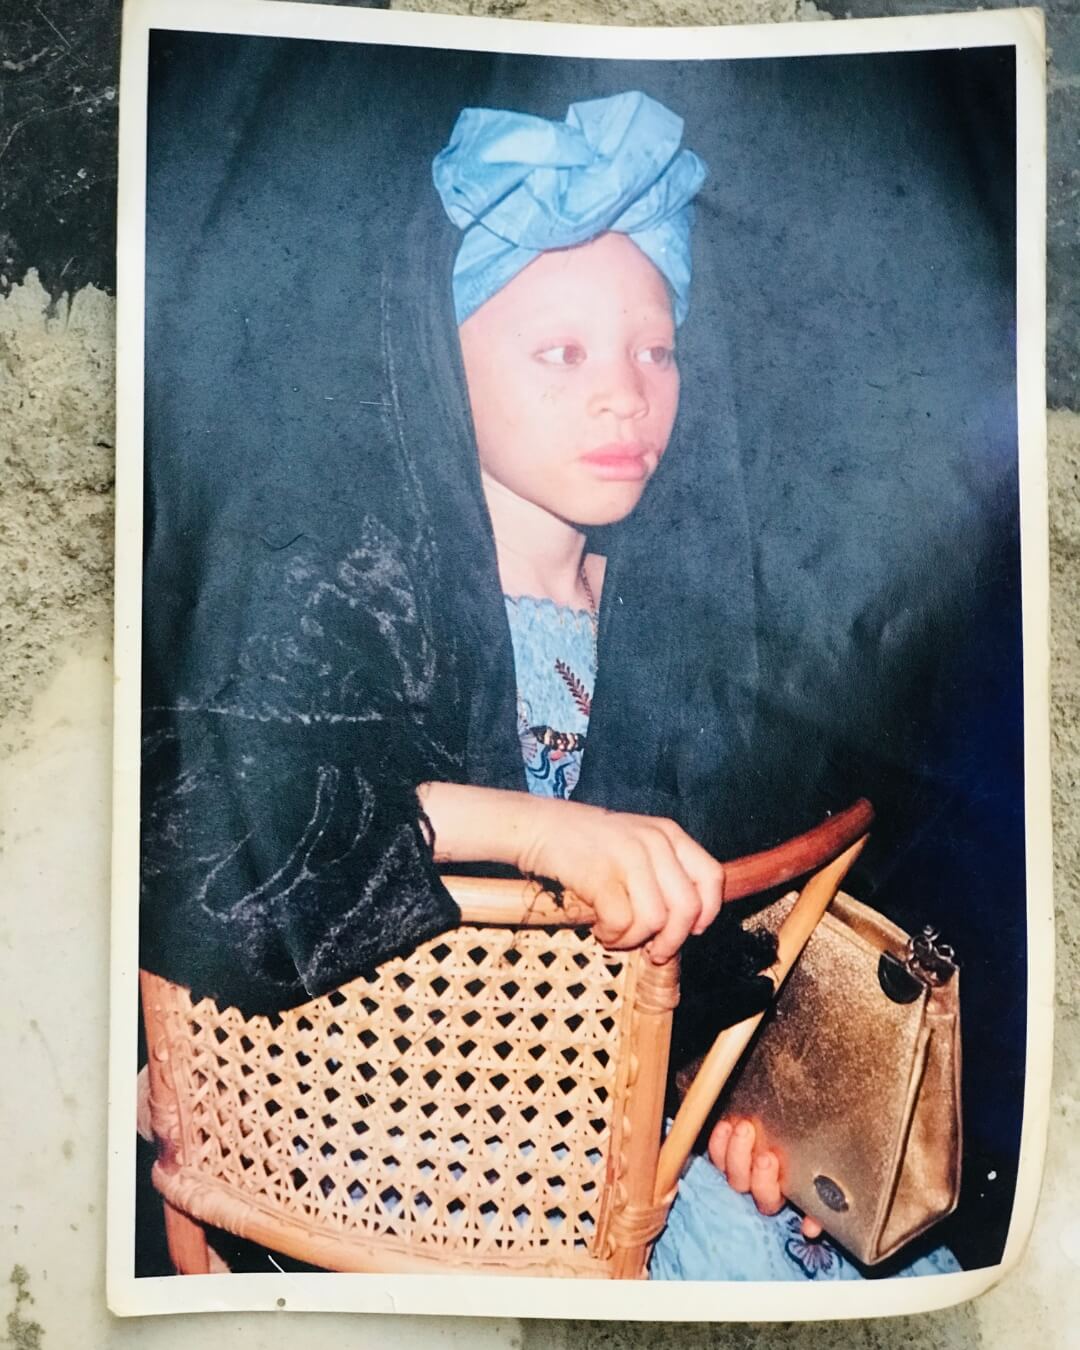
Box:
(482, 474), (589, 608)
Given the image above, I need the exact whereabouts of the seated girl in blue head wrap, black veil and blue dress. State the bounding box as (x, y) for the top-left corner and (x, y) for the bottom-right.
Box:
(143, 93), (949, 1278)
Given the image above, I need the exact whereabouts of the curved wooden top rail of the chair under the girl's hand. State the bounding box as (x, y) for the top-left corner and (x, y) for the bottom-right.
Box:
(443, 798), (873, 927)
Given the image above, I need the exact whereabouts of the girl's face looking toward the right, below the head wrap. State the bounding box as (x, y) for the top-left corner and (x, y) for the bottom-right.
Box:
(459, 234), (679, 525)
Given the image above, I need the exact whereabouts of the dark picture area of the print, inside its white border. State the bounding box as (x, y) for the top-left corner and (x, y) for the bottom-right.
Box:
(124, 2), (1029, 1311)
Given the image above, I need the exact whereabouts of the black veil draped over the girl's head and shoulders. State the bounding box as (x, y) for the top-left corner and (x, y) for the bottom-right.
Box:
(143, 134), (768, 1018)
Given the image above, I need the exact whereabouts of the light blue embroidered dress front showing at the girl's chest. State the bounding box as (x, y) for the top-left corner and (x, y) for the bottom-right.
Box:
(505, 595), (597, 799)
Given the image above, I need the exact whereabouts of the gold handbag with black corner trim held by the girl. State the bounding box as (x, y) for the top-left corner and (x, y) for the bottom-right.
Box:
(721, 892), (961, 1265)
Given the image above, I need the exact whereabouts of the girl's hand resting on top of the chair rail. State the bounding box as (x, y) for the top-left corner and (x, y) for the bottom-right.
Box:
(517, 799), (724, 965)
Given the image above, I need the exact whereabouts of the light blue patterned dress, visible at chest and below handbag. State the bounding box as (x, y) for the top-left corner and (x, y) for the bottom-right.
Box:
(505, 595), (960, 1281)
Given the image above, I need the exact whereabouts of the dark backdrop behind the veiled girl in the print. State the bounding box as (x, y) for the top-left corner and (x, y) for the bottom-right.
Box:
(138, 34), (1027, 1274)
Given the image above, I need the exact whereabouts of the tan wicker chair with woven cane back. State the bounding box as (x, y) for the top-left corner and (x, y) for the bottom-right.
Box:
(140, 802), (871, 1278)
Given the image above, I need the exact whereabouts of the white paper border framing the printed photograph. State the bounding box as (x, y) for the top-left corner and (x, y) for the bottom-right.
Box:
(107, 0), (1054, 1322)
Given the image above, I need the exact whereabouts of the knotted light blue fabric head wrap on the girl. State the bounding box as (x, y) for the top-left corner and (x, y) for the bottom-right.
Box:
(432, 93), (706, 324)
